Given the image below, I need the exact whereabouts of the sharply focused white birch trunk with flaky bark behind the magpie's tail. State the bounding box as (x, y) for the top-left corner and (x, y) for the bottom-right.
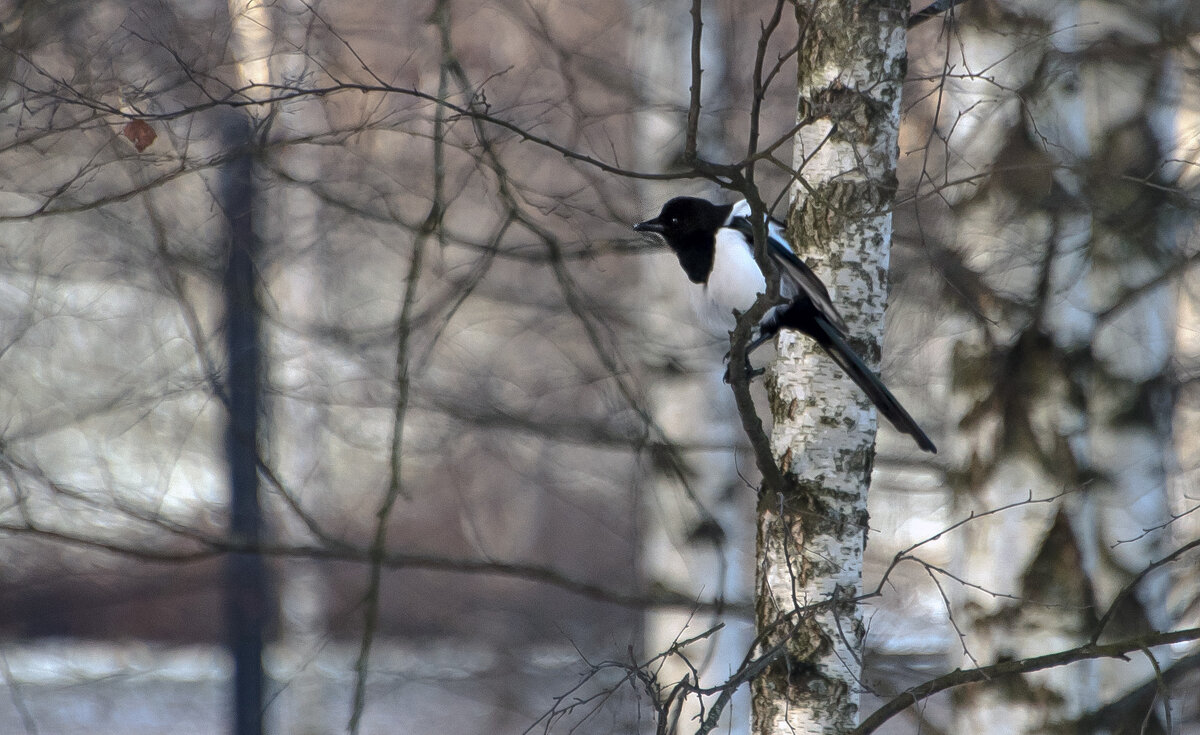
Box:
(752, 0), (907, 735)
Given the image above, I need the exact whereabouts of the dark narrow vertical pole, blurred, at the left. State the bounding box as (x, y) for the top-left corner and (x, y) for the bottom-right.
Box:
(217, 114), (268, 735)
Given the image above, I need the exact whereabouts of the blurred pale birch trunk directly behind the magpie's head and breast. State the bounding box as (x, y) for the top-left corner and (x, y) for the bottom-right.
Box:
(630, 0), (754, 735)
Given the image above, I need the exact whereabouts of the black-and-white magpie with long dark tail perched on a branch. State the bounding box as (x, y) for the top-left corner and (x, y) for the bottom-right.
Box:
(634, 197), (937, 454)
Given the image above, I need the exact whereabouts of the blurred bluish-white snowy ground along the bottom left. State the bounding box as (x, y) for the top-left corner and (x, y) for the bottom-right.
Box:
(0, 641), (648, 735)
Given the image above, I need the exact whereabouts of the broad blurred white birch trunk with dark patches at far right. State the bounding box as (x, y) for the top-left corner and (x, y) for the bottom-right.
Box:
(931, 1), (1184, 733)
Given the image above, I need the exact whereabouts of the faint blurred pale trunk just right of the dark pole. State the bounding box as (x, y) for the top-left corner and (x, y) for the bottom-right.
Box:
(260, 0), (344, 733)
